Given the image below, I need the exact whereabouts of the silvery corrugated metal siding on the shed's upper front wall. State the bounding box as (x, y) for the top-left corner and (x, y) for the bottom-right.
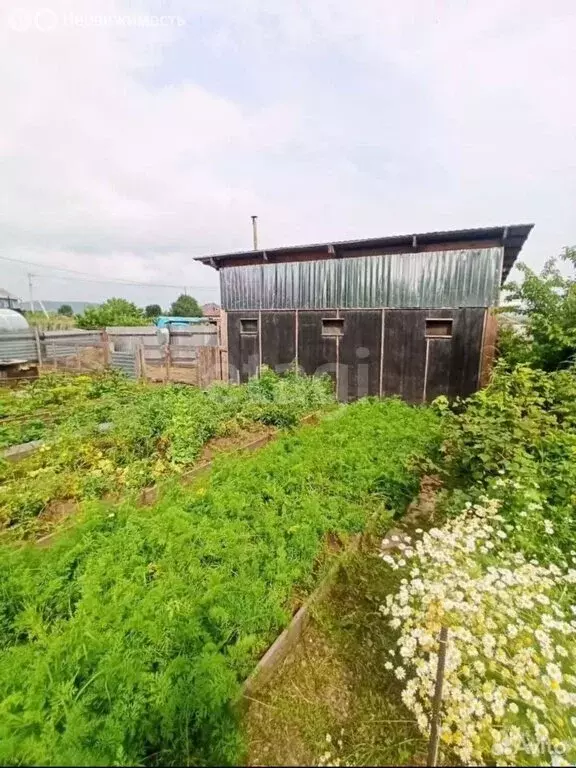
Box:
(220, 248), (503, 310)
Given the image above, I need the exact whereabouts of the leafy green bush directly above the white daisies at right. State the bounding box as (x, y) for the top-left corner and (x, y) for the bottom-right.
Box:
(434, 366), (576, 562)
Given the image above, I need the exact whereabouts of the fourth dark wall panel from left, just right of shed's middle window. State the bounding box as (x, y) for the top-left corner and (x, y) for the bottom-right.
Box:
(340, 309), (382, 400)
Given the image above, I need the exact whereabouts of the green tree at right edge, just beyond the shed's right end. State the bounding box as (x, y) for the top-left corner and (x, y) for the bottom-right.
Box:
(499, 248), (576, 371)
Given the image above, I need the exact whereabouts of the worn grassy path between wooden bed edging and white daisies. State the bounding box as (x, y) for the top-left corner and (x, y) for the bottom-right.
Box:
(244, 552), (427, 765)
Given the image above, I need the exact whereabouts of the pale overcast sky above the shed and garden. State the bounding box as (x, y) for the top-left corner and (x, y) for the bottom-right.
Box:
(0, 0), (576, 304)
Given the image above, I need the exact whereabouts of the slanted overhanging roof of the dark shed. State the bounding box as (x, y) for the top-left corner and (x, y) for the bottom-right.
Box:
(196, 224), (534, 280)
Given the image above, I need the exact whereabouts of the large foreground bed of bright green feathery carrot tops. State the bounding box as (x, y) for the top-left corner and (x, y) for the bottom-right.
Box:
(0, 401), (438, 764)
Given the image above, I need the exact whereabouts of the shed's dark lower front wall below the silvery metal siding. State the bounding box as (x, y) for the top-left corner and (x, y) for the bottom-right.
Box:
(228, 307), (486, 403)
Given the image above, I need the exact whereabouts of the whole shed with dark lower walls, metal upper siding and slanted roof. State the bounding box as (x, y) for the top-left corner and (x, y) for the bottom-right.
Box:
(197, 224), (533, 402)
